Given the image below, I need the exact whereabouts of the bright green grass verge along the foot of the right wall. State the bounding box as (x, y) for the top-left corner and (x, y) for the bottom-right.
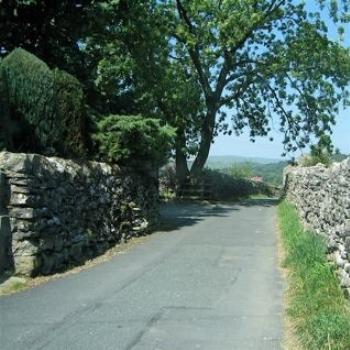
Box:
(278, 201), (350, 350)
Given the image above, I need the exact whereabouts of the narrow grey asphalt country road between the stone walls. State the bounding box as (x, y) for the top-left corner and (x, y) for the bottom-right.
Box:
(0, 201), (282, 350)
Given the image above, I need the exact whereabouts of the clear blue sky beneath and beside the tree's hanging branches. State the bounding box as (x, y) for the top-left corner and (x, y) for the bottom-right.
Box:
(210, 2), (350, 158)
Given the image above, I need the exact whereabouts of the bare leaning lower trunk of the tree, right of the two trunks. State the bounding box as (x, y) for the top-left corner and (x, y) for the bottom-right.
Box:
(190, 108), (216, 177)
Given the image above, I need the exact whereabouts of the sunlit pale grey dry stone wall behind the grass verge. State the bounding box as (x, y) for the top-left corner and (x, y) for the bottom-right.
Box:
(284, 158), (350, 289)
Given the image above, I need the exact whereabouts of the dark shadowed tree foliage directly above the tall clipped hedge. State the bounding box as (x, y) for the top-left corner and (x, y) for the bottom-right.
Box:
(0, 0), (95, 78)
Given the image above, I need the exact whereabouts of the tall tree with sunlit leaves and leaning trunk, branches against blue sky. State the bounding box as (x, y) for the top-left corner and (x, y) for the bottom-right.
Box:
(162, 0), (350, 175)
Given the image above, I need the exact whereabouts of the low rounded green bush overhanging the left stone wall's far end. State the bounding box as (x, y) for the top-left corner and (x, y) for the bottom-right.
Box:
(95, 115), (175, 165)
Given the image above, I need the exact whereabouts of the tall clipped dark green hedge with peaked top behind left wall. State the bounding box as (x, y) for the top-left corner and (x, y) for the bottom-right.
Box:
(0, 49), (85, 157)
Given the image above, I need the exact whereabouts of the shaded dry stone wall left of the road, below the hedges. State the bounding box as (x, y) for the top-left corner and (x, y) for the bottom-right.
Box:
(0, 152), (158, 276)
